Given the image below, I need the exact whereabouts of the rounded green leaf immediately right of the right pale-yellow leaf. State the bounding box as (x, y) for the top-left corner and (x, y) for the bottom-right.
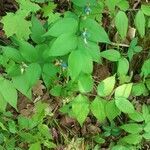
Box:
(131, 83), (148, 96)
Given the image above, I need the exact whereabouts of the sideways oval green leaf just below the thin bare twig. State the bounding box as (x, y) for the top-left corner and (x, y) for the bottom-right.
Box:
(100, 49), (121, 61)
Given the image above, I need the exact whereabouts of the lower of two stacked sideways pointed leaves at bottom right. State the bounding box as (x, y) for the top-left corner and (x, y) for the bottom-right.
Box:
(121, 134), (142, 145)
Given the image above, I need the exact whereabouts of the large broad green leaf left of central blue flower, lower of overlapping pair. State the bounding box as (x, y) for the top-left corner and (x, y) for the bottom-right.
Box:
(49, 33), (77, 56)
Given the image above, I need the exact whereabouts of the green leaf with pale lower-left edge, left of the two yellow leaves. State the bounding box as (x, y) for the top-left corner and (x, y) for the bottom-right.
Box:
(78, 74), (94, 93)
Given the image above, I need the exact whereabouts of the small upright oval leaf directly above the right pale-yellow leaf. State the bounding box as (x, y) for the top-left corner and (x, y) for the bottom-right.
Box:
(117, 57), (129, 76)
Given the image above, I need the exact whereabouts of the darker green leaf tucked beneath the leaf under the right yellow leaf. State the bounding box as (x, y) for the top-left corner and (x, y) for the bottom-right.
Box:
(105, 100), (120, 121)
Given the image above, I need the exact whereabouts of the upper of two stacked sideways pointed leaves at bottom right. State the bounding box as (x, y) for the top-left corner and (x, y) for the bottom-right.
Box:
(121, 123), (143, 134)
